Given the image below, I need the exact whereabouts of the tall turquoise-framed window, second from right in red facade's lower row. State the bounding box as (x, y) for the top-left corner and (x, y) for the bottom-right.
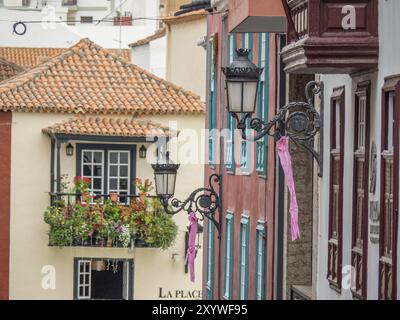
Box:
(239, 215), (250, 300)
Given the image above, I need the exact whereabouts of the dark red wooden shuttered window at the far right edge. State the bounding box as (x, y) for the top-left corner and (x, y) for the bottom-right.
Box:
(378, 76), (400, 300)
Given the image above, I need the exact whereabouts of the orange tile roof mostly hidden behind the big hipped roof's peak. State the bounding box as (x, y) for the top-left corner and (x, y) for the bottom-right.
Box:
(0, 47), (131, 68)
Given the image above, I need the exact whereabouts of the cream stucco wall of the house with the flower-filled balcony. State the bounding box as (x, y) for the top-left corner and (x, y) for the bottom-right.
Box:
(10, 112), (204, 299)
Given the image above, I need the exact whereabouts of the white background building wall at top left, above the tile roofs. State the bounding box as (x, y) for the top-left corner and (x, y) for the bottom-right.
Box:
(0, 0), (159, 49)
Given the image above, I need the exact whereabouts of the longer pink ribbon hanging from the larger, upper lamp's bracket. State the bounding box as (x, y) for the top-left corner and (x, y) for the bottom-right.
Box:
(276, 137), (300, 241)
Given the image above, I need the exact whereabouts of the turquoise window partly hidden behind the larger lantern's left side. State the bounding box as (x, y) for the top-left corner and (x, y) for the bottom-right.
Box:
(225, 33), (236, 174)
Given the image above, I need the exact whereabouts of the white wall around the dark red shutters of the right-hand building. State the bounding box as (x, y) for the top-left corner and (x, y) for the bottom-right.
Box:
(317, 0), (400, 299)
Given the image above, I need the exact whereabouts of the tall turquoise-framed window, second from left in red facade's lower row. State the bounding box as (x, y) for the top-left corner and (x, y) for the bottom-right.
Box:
(224, 211), (235, 300)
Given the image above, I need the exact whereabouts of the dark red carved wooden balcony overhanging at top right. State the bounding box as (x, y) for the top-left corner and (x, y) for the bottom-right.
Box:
(282, 0), (379, 74)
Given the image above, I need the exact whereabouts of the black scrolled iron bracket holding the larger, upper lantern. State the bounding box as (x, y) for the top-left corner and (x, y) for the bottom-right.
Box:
(233, 81), (323, 177)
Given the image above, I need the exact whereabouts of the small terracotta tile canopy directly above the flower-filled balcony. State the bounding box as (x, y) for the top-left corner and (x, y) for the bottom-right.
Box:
(43, 116), (177, 137)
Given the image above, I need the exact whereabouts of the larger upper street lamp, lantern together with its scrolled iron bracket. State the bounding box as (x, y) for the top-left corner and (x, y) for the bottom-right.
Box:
(222, 49), (323, 177)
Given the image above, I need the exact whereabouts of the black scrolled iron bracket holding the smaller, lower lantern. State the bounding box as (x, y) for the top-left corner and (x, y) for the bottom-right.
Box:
(160, 173), (222, 232)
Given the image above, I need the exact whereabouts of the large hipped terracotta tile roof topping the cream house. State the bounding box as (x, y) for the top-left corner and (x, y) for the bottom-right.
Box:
(0, 39), (204, 115)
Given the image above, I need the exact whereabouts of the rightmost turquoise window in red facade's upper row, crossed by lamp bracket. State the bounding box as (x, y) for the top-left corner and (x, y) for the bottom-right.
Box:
(256, 33), (269, 177)
